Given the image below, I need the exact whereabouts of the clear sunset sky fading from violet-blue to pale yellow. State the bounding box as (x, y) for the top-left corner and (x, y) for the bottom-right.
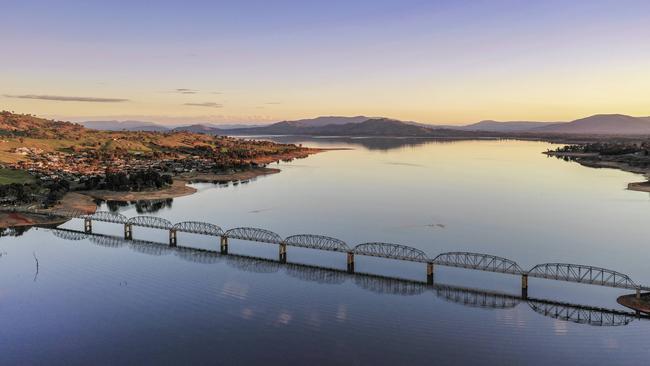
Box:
(0, 0), (650, 124)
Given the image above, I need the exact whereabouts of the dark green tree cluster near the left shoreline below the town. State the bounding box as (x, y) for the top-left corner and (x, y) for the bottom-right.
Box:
(83, 169), (173, 191)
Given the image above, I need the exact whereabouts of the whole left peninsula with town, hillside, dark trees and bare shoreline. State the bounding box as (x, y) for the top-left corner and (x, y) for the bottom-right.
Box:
(0, 111), (322, 228)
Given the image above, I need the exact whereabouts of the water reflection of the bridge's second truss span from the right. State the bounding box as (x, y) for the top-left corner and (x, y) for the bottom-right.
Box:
(435, 286), (520, 309)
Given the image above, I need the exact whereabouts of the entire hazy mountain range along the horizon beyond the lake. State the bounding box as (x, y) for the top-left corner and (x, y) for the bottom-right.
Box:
(81, 114), (650, 137)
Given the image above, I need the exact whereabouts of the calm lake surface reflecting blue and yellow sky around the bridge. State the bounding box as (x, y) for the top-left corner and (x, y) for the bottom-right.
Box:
(0, 139), (650, 365)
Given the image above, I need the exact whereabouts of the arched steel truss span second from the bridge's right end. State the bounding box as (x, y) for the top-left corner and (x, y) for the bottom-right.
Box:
(433, 252), (524, 275)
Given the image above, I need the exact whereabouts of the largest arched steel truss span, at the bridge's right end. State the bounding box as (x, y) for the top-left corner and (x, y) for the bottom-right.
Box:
(528, 263), (642, 290)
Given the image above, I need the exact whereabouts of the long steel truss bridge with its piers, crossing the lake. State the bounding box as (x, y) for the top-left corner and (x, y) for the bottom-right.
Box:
(59, 211), (650, 296)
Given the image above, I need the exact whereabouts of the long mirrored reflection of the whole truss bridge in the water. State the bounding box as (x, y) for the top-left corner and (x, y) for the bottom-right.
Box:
(51, 229), (649, 326)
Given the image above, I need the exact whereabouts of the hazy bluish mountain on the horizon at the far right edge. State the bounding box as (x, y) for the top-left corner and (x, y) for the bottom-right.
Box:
(530, 114), (650, 135)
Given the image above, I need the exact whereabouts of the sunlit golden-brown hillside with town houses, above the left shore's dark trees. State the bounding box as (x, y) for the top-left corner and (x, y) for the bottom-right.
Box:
(0, 111), (312, 164)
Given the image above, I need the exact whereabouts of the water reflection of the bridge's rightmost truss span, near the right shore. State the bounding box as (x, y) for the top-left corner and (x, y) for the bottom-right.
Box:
(528, 300), (635, 326)
